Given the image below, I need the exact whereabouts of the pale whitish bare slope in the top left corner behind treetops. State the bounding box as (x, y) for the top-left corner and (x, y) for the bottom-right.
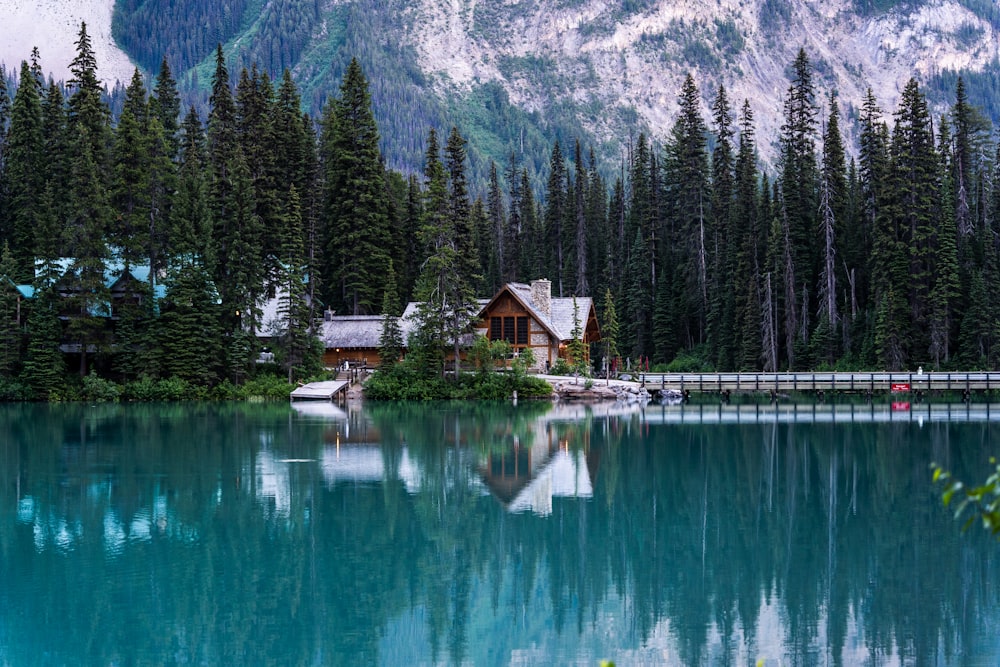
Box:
(0, 0), (135, 86)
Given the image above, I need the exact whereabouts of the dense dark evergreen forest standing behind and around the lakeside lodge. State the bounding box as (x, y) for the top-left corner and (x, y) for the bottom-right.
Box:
(0, 24), (1000, 398)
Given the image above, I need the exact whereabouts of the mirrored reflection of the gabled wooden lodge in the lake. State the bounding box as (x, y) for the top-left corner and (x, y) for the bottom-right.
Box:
(479, 420), (599, 516)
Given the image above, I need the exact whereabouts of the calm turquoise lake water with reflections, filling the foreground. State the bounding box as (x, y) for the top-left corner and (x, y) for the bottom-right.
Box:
(0, 402), (1000, 666)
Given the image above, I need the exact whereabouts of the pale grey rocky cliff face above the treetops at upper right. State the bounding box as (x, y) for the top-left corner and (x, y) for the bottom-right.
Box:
(406, 0), (1000, 153)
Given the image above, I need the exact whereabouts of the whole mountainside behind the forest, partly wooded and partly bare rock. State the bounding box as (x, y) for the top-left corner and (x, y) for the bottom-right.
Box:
(0, 0), (1000, 172)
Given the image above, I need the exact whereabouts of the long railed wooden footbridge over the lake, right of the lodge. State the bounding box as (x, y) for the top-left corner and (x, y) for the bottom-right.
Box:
(639, 371), (1000, 398)
